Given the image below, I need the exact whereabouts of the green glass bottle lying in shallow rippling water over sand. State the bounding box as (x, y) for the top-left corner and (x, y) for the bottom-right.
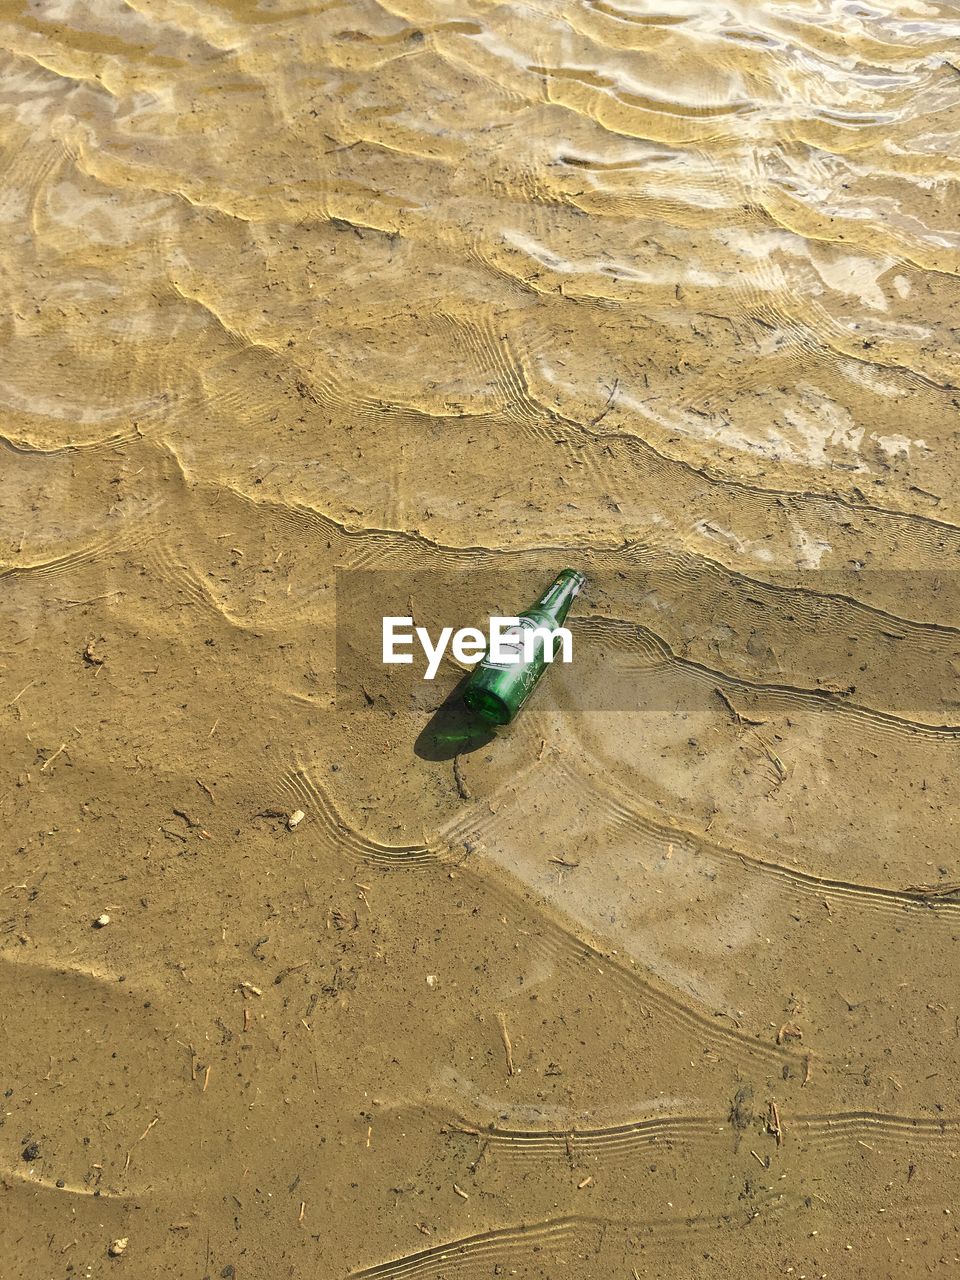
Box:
(463, 568), (586, 724)
